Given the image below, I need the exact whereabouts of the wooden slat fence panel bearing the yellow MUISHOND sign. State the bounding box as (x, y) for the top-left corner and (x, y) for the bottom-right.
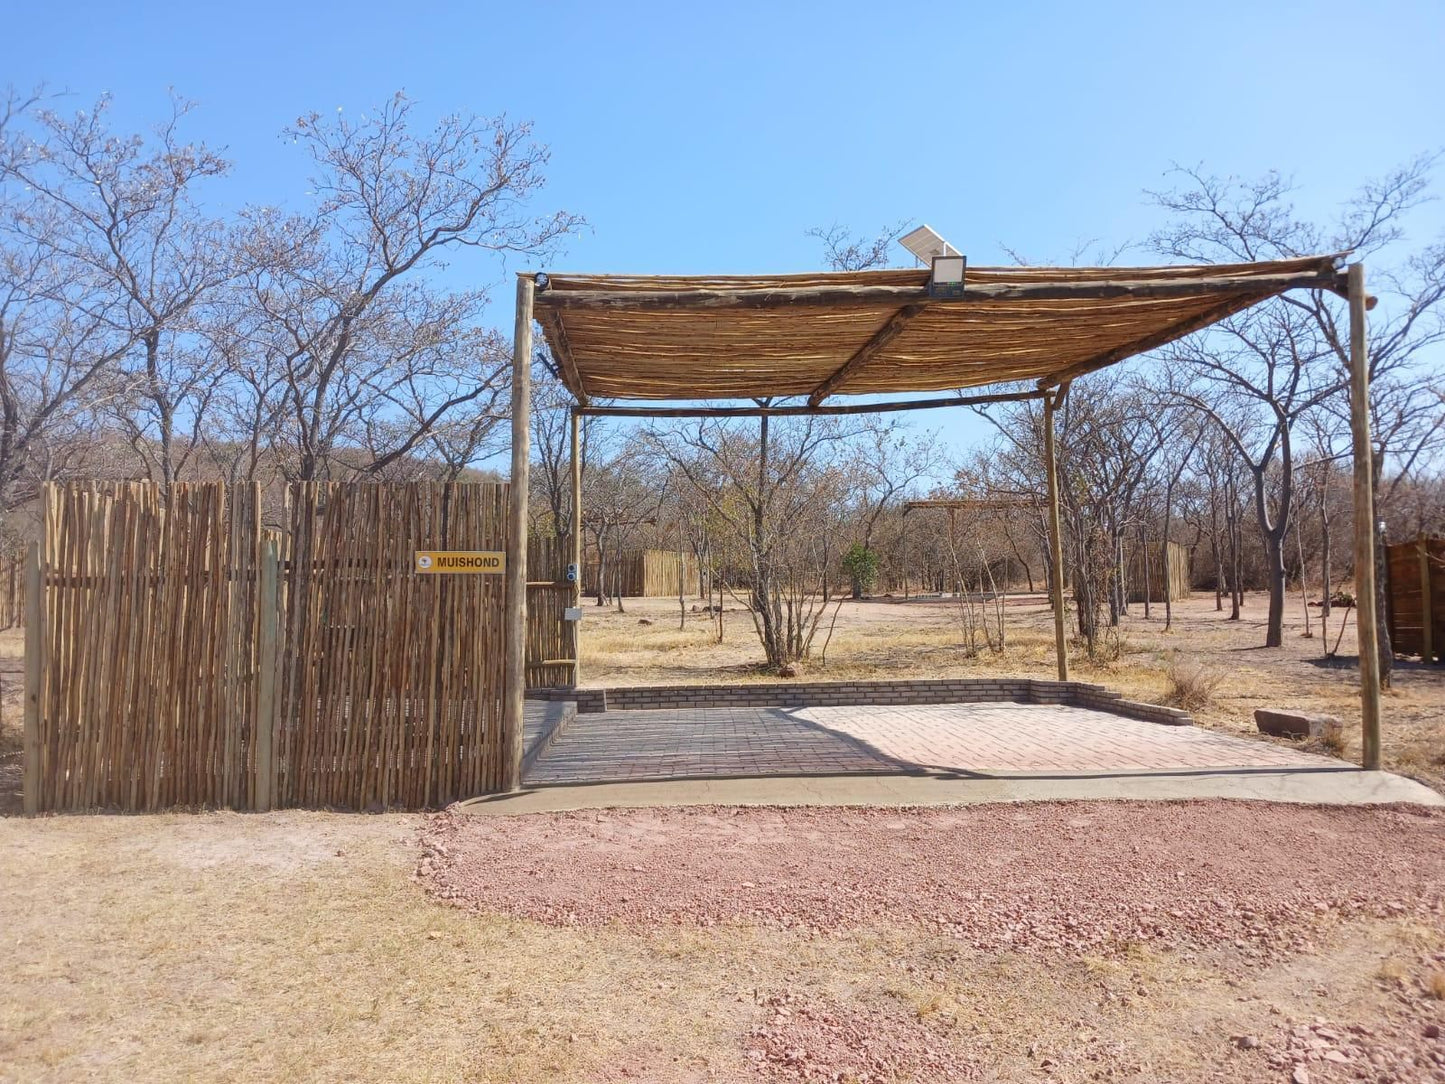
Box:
(276, 483), (507, 809)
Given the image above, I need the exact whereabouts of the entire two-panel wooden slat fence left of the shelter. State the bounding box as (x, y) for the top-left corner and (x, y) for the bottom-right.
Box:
(25, 483), (507, 811)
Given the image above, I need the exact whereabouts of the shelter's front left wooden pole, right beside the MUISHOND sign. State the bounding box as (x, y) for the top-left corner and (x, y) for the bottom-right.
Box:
(501, 275), (536, 791)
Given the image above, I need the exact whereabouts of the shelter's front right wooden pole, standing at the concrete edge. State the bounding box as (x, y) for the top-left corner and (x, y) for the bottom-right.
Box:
(1348, 263), (1380, 770)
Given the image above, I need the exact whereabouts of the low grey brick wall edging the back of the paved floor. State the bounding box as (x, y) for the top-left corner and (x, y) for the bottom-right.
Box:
(527, 678), (1194, 726)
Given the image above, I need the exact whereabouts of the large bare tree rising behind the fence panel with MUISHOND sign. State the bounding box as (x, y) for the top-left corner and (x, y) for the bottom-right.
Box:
(246, 94), (581, 480)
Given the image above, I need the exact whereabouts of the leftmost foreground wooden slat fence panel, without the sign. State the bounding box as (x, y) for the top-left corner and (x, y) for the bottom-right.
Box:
(26, 484), (259, 809)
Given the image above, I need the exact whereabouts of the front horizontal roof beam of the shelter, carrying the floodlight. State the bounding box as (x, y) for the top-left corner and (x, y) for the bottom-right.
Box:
(536, 266), (1345, 312)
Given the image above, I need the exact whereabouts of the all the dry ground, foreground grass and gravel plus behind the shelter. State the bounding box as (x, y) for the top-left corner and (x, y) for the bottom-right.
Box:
(0, 598), (1445, 1084)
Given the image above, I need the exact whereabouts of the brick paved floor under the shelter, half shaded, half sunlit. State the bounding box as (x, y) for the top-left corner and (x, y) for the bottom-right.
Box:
(527, 704), (1340, 785)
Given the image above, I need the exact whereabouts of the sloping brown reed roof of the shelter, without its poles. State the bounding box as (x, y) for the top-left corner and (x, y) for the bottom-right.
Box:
(533, 254), (1345, 413)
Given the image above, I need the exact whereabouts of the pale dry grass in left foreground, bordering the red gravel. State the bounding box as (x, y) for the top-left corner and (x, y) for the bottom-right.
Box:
(0, 812), (768, 1084)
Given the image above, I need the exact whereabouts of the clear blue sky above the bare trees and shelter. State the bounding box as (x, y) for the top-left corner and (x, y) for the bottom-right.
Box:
(11, 0), (1445, 471)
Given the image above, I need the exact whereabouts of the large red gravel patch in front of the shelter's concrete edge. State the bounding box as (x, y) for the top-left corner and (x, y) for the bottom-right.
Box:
(418, 801), (1445, 955)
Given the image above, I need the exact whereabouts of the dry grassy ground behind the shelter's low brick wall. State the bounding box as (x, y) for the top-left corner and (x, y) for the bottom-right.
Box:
(582, 594), (1445, 791)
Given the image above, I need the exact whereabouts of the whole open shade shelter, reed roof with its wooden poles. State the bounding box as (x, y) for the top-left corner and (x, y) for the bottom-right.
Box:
(506, 253), (1380, 789)
